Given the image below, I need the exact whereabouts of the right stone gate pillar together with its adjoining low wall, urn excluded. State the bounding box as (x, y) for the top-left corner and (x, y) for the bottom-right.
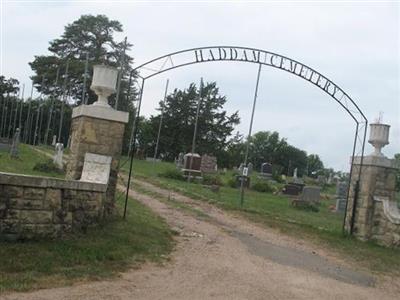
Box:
(345, 156), (400, 247)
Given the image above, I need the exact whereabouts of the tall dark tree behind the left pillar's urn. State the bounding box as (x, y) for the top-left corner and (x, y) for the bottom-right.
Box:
(29, 15), (134, 111)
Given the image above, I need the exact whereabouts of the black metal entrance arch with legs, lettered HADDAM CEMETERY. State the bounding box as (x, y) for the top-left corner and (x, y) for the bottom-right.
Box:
(124, 46), (368, 234)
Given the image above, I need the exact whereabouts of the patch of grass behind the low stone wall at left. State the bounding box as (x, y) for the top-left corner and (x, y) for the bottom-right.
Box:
(0, 144), (64, 178)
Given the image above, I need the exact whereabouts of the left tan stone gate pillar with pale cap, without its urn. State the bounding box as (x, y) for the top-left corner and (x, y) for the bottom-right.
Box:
(66, 105), (129, 213)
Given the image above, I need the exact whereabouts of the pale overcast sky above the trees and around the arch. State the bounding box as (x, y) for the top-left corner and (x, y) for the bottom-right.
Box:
(0, 0), (400, 171)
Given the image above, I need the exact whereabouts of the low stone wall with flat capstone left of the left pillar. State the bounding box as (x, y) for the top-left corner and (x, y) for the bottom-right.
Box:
(0, 173), (107, 240)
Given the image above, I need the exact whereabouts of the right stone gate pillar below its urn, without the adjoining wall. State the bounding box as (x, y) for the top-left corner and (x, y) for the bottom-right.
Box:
(345, 155), (398, 240)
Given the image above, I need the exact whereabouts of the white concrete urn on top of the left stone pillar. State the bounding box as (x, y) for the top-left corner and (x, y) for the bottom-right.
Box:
(90, 65), (118, 107)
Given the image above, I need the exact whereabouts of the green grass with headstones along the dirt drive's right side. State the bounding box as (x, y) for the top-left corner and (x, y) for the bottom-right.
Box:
(122, 160), (400, 275)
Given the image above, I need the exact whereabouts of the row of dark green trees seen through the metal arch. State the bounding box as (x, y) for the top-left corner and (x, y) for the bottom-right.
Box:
(137, 82), (324, 176)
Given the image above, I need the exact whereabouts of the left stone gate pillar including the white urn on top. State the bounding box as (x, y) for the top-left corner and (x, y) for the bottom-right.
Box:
(66, 65), (129, 214)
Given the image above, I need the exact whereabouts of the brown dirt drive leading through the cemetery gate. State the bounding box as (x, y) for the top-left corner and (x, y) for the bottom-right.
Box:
(0, 181), (400, 300)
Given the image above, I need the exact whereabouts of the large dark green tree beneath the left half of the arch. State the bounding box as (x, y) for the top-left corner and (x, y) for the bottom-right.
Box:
(138, 82), (239, 161)
